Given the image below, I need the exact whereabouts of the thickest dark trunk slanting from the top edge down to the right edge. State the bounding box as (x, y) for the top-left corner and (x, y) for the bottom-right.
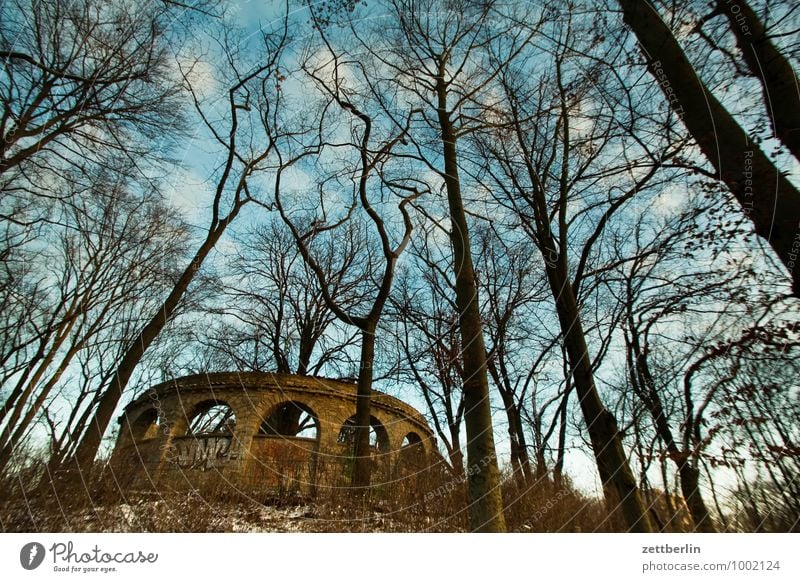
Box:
(618, 0), (800, 295)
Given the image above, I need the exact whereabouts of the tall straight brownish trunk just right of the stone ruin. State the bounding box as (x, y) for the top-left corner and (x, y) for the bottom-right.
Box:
(436, 63), (506, 532)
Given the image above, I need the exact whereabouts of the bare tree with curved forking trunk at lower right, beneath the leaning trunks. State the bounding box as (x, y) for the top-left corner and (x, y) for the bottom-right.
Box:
(615, 188), (796, 532)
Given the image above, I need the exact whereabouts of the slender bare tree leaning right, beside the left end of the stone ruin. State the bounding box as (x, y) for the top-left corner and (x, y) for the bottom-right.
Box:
(62, 20), (304, 474)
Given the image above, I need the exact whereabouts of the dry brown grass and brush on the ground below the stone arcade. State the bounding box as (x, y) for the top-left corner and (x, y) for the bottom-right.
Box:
(0, 462), (780, 532)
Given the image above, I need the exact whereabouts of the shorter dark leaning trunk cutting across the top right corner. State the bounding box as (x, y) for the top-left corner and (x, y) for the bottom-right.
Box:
(717, 0), (800, 160)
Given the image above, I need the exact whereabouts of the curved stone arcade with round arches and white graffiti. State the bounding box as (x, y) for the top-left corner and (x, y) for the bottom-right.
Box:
(112, 372), (436, 492)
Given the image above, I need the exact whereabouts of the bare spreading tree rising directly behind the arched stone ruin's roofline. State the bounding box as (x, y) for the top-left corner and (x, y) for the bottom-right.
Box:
(198, 220), (365, 375)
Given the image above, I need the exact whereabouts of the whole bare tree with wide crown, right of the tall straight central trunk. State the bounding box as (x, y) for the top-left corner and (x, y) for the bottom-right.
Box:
(466, 8), (708, 531)
